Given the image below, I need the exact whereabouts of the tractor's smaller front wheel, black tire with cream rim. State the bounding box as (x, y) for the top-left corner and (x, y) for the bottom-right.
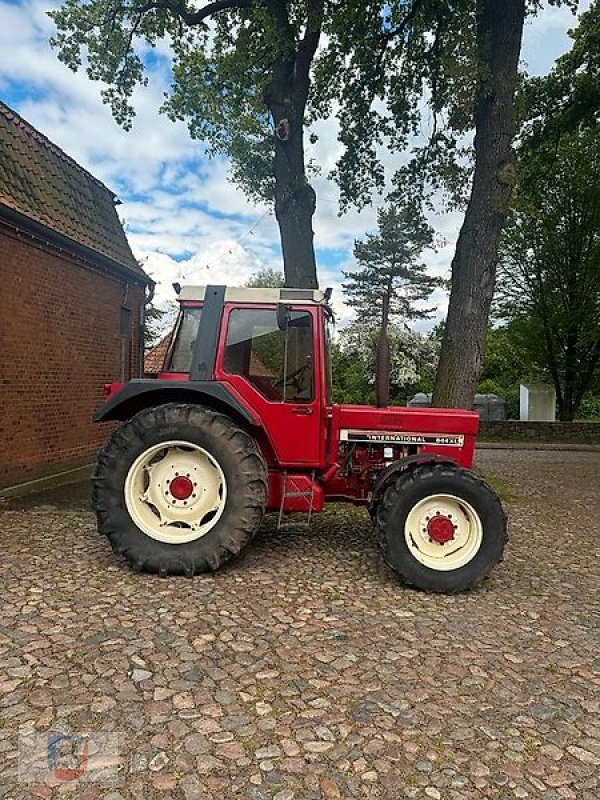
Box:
(376, 464), (507, 593)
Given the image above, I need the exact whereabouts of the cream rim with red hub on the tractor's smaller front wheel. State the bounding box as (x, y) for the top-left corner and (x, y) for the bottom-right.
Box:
(404, 494), (483, 572)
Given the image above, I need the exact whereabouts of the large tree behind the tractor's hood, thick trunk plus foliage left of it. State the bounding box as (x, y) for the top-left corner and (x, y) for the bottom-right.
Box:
(317, 0), (577, 407)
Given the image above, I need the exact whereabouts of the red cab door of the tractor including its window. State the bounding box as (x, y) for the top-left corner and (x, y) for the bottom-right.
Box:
(216, 305), (322, 467)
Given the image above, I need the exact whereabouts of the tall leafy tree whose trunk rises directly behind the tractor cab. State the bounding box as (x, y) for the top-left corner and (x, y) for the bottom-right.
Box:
(50, 0), (326, 287)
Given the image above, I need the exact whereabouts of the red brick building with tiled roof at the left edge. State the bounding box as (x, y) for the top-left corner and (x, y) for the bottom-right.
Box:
(0, 103), (152, 489)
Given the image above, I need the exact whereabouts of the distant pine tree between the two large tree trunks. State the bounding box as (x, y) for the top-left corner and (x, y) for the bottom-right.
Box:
(343, 205), (440, 324)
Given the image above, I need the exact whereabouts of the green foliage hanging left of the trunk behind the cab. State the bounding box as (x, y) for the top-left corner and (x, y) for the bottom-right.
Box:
(49, 0), (298, 206)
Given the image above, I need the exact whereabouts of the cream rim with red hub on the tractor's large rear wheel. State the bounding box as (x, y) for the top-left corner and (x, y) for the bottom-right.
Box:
(125, 441), (227, 544)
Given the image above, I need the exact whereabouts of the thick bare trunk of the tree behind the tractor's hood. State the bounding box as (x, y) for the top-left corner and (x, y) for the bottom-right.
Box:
(433, 0), (525, 408)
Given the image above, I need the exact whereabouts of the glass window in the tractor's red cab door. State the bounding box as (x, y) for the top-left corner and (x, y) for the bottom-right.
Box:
(223, 308), (313, 403)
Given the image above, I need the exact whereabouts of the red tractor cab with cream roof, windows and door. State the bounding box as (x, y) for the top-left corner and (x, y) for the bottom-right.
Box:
(157, 286), (332, 467)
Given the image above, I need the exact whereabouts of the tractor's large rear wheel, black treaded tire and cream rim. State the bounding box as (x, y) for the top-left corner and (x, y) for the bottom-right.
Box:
(92, 403), (267, 576)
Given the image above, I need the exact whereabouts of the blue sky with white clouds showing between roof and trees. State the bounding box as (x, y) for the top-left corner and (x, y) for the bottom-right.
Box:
(0, 0), (589, 330)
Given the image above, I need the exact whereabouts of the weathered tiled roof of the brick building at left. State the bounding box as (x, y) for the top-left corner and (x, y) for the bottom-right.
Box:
(0, 102), (144, 275)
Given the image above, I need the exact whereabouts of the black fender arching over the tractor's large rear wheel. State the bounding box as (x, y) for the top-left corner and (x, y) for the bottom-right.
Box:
(92, 379), (260, 425)
